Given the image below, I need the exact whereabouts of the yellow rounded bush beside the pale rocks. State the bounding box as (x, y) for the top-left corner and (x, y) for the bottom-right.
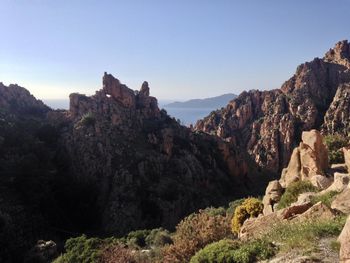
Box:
(232, 197), (264, 233)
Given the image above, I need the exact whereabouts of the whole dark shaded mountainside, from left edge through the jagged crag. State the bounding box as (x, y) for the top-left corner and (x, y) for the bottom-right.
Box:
(0, 74), (253, 262)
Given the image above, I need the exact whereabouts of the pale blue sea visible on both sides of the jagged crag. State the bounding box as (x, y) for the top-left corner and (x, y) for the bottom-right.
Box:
(42, 99), (213, 126)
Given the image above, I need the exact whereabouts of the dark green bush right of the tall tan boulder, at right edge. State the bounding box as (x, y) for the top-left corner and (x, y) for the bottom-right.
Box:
(324, 134), (349, 164)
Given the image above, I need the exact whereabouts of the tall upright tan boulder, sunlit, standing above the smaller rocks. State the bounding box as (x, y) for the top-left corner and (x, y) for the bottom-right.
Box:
(280, 130), (330, 188)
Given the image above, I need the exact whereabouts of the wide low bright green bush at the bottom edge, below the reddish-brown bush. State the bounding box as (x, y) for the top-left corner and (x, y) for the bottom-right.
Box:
(190, 239), (276, 263)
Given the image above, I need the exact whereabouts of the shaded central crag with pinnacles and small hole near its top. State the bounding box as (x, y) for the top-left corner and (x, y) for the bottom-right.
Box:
(62, 74), (252, 233)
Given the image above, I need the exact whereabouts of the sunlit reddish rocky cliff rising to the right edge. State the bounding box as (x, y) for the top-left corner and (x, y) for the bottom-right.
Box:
(195, 41), (350, 172)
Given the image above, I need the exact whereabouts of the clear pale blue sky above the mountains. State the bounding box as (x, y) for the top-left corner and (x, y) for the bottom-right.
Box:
(0, 0), (350, 100)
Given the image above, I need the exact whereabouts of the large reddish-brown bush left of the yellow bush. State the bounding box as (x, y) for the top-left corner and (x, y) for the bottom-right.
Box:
(162, 210), (230, 263)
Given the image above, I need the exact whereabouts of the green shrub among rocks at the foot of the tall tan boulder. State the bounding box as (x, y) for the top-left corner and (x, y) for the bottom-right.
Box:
(277, 181), (317, 209)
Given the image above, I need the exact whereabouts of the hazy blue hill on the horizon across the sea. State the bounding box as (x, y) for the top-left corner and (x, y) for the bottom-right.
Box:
(164, 93), (237, 110)
